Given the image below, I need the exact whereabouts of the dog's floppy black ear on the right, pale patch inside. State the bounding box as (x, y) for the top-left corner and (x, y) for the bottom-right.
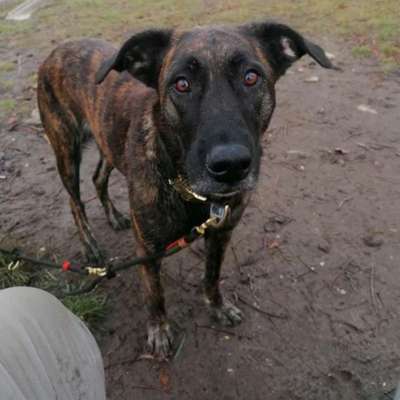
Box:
(240, 22), (338, 76)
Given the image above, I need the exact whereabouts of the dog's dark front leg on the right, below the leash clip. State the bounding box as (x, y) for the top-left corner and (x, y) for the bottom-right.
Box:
(204, 230), (242, 326)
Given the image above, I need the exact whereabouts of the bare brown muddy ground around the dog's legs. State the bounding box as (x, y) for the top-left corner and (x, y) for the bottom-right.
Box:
(0, 34), (400, 400)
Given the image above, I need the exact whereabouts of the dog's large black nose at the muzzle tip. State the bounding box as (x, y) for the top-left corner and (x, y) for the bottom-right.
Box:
(206, 144), (251, 183)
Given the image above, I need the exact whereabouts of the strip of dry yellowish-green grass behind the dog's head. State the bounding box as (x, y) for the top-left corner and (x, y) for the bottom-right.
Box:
(0, 0), (400, 65)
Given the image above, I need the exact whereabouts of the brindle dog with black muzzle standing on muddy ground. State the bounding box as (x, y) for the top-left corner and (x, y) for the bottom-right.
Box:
(38, 22), (333, 357)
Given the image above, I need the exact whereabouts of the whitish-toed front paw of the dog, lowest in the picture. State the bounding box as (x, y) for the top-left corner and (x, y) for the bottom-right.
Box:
(147, 321), (176, 361)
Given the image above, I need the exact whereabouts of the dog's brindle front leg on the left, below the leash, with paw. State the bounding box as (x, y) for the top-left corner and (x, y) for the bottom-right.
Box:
(137, 248), (174, 360)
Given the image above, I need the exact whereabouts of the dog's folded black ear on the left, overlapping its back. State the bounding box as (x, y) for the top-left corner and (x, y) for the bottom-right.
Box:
(96, 30), (172, 88)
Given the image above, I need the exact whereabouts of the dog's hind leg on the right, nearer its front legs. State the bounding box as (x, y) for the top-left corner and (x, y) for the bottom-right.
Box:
(93, 155), (131, 231)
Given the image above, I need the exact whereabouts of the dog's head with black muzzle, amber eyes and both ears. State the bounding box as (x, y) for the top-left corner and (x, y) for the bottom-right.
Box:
(97, 23), (333, 198)
